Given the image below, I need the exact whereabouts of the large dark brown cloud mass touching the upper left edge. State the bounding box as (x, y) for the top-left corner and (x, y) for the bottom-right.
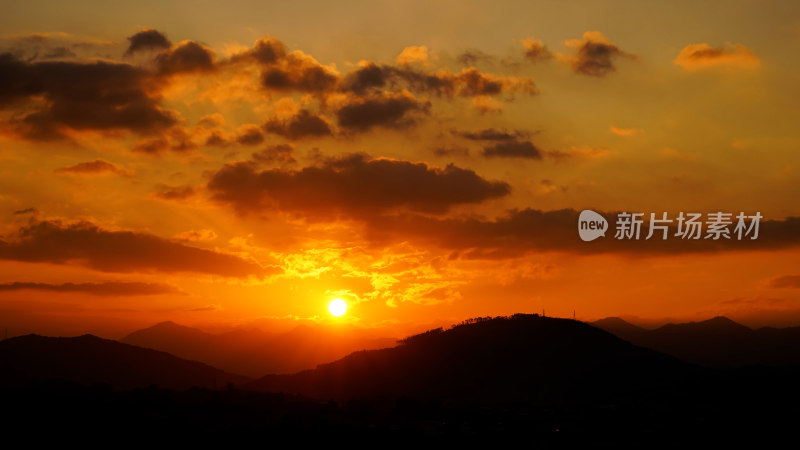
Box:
(0, 54), (177, 139)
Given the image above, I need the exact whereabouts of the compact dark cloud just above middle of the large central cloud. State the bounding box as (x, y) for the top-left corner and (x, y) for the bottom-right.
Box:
(336, 93), (430, 131)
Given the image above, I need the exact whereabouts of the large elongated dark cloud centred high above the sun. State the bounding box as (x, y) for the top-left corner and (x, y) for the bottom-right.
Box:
(208, 154), (510, 217)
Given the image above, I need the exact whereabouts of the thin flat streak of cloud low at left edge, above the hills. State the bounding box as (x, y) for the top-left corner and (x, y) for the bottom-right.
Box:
(0, 281), (181, 297)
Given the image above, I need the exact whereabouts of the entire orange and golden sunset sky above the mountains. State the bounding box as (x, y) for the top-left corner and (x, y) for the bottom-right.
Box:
(0, 0), (800, 337)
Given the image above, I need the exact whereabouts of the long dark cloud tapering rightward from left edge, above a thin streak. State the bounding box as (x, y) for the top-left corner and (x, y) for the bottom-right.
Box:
(0, 220), (274, 277)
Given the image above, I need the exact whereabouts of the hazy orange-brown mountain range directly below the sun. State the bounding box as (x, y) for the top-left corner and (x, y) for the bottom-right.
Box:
(121, 322), (396, 377)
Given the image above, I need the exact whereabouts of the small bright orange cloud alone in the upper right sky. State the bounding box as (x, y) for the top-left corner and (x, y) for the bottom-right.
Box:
(673, 43), (761, 70)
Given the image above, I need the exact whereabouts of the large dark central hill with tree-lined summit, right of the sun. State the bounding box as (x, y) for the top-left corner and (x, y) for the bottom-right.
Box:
(245, 314), (691, 402)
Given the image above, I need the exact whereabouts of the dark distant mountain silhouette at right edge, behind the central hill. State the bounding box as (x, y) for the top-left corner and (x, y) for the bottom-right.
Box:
(592, 316), (800, 367)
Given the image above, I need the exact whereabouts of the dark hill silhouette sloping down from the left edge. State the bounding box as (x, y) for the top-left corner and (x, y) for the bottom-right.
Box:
(0, 334), (249, 389)
